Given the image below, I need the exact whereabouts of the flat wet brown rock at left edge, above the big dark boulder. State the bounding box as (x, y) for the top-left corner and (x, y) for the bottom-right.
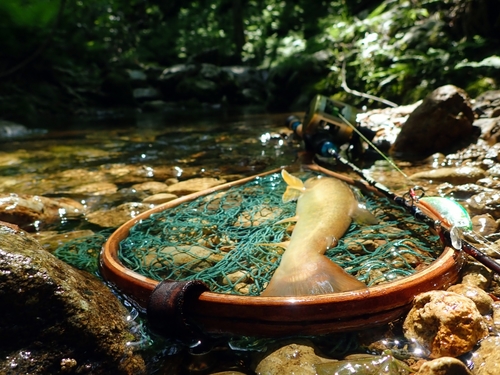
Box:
(0, 194), (85, 231)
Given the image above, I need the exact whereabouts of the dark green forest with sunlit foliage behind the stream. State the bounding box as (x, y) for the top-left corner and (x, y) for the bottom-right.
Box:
(0, 0), (500, 121)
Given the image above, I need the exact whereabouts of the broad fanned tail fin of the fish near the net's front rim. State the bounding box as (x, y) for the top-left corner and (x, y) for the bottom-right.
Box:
(261, 254), (367, 297)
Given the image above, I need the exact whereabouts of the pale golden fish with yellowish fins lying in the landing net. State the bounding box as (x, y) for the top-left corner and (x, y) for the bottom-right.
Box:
(260, 169), (378, 297)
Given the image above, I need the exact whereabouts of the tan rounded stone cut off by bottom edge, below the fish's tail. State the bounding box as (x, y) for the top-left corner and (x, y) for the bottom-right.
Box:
(255, 343), (332, 375)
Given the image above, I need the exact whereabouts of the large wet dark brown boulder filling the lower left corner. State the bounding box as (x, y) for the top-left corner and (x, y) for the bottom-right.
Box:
(0, 224), (145, 375)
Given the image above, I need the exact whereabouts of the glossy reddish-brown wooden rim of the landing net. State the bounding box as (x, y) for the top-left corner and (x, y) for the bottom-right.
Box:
(99, 165), (465, 336)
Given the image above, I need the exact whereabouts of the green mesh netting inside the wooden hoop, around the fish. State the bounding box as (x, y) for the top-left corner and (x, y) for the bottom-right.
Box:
(111, 174), (442, 295)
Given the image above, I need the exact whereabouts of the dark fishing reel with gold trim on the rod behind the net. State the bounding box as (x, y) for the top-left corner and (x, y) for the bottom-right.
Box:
(286, 95), (376, 159)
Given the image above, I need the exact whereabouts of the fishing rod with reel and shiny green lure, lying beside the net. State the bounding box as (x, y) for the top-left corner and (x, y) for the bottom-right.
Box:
(286, 95), (500, 274)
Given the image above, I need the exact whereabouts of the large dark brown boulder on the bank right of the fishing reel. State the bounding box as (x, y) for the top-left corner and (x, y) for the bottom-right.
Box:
(391, 85), (475, 159)
